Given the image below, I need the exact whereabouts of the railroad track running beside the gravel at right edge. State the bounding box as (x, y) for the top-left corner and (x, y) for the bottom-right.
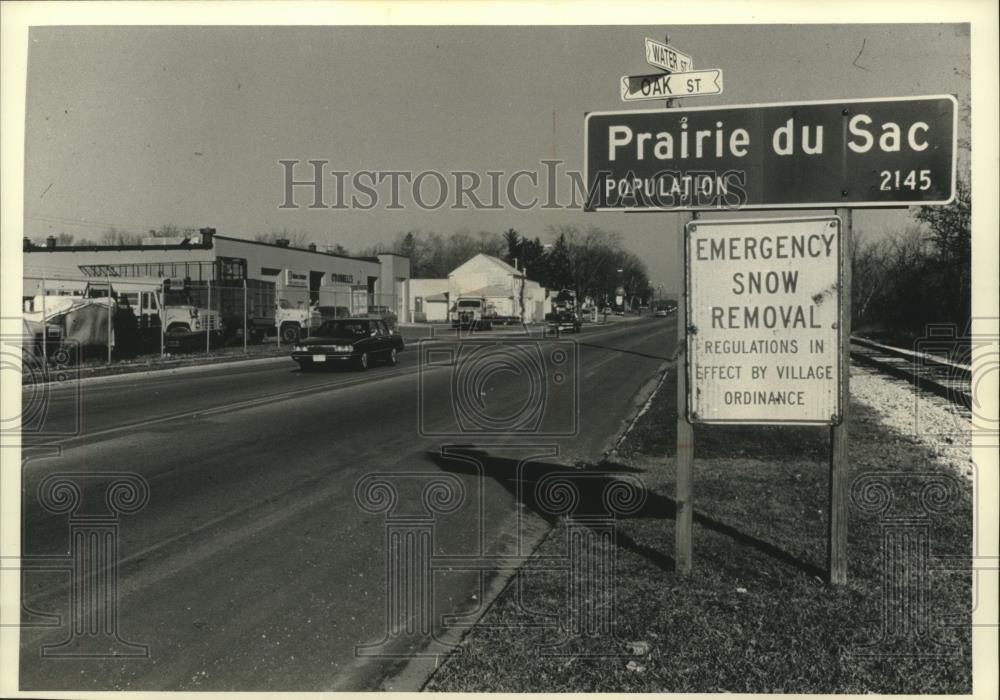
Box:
(851, 336), (972, 410)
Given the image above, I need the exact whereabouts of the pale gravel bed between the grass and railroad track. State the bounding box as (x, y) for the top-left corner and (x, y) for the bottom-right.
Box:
(851, 363), (974, 479)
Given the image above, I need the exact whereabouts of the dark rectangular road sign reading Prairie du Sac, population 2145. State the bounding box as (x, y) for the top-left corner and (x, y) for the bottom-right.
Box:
(584, 95), (957, 211)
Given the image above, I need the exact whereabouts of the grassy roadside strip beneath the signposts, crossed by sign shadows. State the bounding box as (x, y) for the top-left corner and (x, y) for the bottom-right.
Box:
(428, 366), (972, 693)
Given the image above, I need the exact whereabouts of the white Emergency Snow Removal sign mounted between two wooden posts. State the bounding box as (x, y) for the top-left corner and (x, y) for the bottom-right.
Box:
(686, 217), (849, 425)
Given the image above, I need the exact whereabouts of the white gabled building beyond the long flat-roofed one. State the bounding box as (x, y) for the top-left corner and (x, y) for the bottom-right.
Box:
(404, 253), (549, 323)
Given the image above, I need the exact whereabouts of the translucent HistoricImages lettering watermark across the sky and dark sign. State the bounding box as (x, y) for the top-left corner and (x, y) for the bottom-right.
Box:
(278, 159), (747, 211)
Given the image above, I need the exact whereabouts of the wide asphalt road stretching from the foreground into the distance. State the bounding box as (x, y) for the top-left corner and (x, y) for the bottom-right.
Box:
(20, 318), (676, 691)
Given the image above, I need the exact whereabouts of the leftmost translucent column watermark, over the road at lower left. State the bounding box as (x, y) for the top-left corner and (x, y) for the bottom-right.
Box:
(13, 472), (150, 659)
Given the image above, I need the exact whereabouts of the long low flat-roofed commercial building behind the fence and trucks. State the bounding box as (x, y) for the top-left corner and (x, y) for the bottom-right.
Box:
(24, 228), (410, 317)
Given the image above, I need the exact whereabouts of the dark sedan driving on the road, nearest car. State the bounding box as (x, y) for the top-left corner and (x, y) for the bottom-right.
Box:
(292, 318), (403, 371)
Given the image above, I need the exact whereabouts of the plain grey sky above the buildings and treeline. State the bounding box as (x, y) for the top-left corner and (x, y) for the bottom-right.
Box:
(25, 24), (969, 290)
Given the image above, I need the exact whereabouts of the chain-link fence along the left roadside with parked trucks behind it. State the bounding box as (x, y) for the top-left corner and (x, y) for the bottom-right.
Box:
(23, 275), (397, 364)
